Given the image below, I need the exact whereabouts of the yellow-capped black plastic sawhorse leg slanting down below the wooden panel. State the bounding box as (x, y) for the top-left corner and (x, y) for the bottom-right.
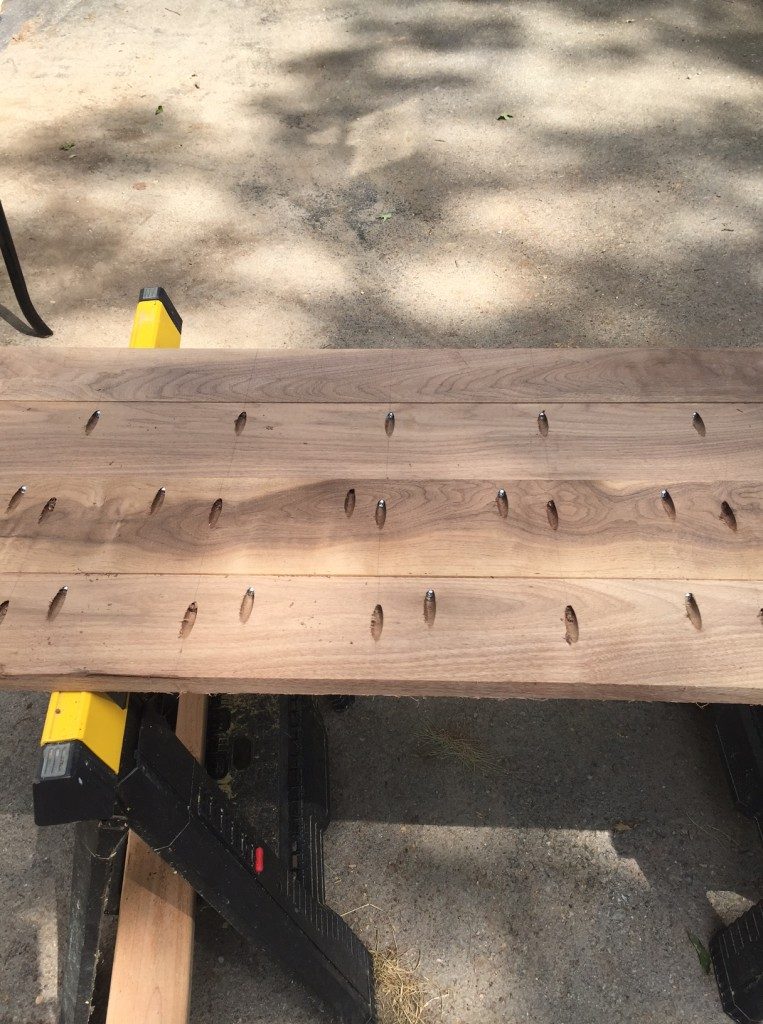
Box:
(34, 693), (375, 1024)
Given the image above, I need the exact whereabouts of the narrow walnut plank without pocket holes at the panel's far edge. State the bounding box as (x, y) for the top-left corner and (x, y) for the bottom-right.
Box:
(0, 347), (763, 403)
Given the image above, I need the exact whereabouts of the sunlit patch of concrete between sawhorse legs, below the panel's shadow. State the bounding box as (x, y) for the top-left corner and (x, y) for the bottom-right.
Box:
(327, 822), (680, 1024)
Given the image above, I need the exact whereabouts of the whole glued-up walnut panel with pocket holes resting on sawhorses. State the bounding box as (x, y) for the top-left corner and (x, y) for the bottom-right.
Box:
(0, 349), (763, 700)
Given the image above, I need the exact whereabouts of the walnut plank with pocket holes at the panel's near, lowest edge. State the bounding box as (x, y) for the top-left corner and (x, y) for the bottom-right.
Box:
(0, 573), (763, 693)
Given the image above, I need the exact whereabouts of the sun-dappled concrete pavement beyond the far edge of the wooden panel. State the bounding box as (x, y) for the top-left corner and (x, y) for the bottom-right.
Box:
(0, 0), (758, 346)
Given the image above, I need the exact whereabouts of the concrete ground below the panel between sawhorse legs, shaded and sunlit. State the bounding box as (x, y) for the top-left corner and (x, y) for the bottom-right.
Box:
(327, 698), (763, 1024)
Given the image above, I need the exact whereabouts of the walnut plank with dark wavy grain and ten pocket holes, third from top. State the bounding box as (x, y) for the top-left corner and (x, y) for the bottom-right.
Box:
(0, 476), (763, 580)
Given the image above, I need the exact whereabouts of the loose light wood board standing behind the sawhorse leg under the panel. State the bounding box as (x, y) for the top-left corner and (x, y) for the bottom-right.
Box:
(107, 693), (206, 1024)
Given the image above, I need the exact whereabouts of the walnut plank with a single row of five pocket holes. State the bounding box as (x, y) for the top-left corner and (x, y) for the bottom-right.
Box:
(0, 402), (763, 483)
